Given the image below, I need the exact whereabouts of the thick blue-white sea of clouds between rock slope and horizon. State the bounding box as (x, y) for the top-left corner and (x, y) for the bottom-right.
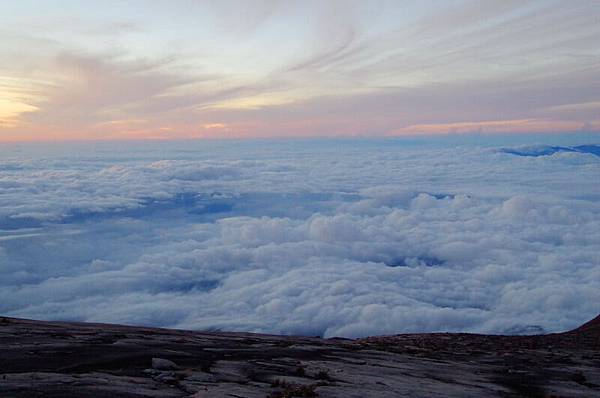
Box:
(0, 135), (600, 337)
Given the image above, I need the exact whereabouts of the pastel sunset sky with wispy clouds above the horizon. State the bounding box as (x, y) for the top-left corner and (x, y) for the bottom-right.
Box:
(0, 0), (600, 141)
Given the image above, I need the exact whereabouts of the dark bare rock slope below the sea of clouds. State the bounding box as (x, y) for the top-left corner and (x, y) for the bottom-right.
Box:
(0, 317), (600, 398)
